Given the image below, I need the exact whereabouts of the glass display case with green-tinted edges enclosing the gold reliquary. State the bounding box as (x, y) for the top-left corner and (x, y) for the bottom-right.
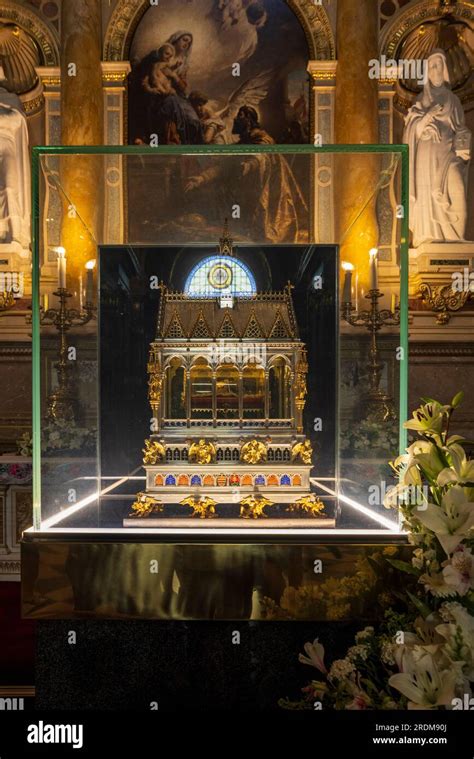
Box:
(28, 145), (408, 542)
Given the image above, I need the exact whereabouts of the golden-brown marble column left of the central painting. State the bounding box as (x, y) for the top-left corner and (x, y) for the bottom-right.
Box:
(60, 0), (104, 280)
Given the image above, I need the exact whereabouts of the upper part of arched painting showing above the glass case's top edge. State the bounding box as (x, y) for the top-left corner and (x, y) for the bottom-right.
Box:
(128, 0), (309, 145)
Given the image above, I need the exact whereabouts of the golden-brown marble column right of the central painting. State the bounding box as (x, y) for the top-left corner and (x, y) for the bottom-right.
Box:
(335, 0), (380, 289)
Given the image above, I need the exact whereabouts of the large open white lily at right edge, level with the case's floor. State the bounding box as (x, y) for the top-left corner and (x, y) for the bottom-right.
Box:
(417, 485), (474, 556)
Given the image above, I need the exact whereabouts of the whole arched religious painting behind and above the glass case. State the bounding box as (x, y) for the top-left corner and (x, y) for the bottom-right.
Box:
(127, 0), (310, 243)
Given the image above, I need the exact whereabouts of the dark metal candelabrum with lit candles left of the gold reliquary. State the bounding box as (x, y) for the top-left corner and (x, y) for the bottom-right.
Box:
(40, 287), (96, 422)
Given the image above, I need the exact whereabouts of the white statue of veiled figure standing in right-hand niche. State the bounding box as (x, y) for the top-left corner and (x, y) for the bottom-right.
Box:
(403, 50), (471, 248)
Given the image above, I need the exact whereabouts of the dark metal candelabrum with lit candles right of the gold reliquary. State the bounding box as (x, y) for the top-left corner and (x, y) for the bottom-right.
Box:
(341, 288), (400, 421)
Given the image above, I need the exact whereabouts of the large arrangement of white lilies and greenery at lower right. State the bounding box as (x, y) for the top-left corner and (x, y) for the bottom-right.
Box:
(279, 393), (474, 709)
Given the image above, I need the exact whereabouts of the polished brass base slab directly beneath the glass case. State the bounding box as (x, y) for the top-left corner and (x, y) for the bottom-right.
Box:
(21, 536), (412, 621)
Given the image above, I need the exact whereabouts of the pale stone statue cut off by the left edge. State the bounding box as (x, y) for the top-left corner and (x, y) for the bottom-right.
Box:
(0, 66), (30, 248)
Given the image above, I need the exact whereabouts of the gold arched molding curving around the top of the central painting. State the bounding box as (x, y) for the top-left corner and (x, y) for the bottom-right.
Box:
(103, 0), (336, 61)
